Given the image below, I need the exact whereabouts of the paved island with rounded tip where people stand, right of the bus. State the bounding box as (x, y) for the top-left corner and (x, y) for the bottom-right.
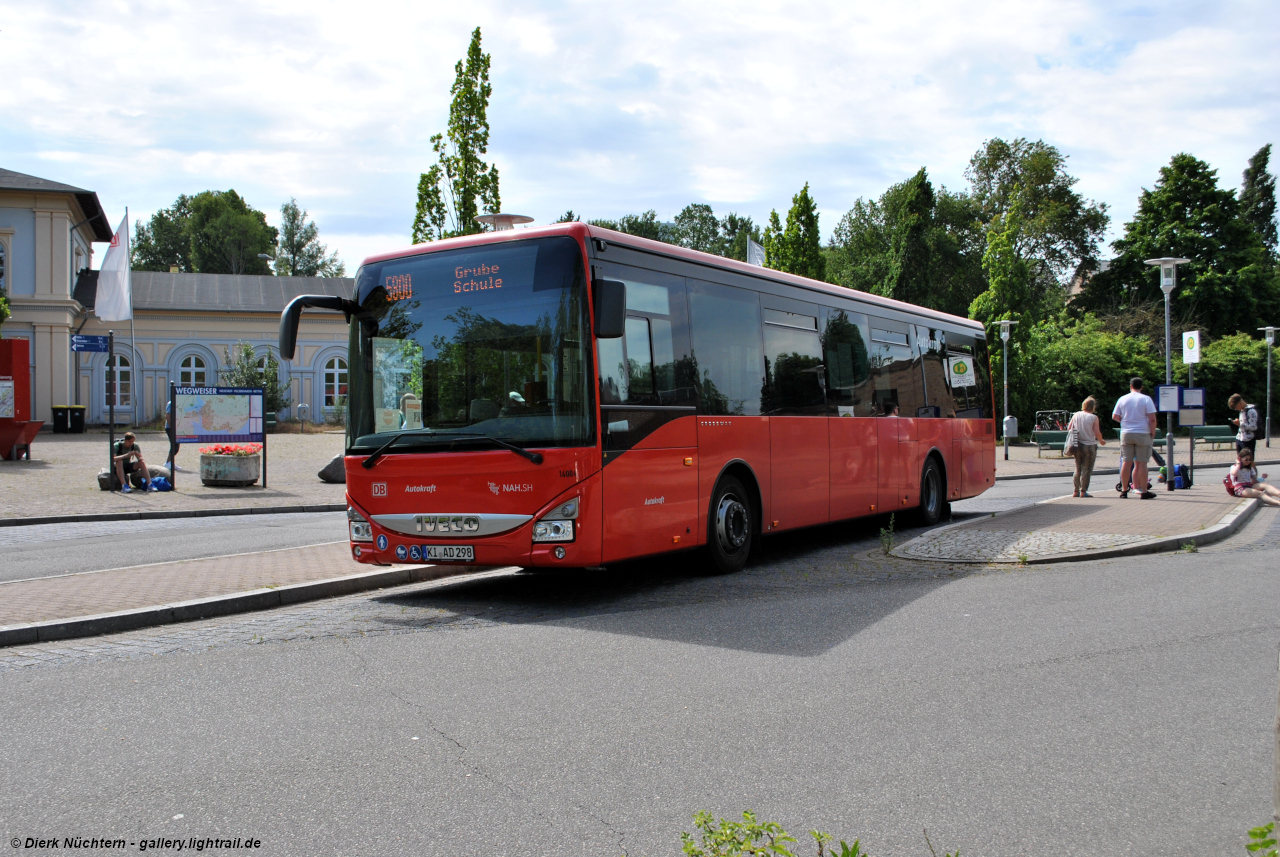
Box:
(893, 476), (1257, 563)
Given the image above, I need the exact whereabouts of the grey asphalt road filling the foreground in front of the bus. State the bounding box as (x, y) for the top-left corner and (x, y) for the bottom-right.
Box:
(0, 475), (1280, 857)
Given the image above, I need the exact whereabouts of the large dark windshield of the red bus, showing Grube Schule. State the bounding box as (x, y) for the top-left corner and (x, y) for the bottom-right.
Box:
(347, 237), (594, 452)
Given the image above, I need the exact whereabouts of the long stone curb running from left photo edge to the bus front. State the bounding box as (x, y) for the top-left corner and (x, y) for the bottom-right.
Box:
(0, 565), (492, 647)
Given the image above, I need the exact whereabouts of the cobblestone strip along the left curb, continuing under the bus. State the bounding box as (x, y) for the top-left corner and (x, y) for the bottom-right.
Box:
(0, 526), (983, 672)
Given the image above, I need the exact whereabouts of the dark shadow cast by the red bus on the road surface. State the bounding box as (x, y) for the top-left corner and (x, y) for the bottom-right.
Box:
(378, 519), (968, 657)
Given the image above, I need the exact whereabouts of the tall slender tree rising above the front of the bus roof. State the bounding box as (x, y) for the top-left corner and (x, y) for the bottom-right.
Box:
(413, 27), (502, 243)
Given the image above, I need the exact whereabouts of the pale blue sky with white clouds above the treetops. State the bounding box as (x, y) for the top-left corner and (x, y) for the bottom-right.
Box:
(0, 0), (1280, 270)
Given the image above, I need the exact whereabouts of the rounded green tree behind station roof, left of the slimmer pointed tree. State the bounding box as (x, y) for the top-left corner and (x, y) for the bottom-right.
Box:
(187, 191), (278, 274)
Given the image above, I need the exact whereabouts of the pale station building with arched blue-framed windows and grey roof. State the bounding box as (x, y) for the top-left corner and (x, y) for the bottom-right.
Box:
(0, 170), (355, 427)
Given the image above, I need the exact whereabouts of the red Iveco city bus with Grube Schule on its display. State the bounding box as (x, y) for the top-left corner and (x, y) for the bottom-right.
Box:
(280, 223), (996, 572)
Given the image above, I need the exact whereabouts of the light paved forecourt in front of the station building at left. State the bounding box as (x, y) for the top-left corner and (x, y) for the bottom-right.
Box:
(0, 431), (347, 519)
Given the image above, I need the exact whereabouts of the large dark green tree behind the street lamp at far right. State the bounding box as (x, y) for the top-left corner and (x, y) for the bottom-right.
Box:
(1073, 153), (1280, 345)
